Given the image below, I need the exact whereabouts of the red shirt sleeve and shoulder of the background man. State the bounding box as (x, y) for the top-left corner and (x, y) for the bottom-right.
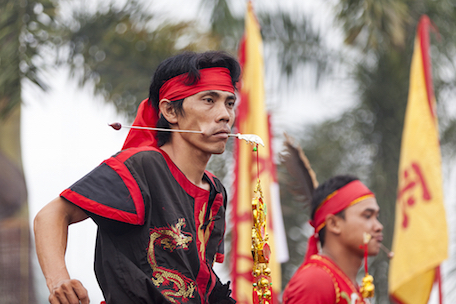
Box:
(283, 266), (336, 304)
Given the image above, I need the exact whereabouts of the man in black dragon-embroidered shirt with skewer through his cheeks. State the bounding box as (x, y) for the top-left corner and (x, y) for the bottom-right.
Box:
(35, 52), (240, 304)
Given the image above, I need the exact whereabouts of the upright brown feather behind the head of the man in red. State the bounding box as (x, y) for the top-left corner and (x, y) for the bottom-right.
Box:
(281, 133), (318, 206)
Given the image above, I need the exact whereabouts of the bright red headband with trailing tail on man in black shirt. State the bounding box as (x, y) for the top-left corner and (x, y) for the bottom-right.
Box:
(122, 68), (234, 150)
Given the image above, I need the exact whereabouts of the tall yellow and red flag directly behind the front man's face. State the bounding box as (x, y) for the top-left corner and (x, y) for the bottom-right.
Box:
(230, 2), (286, 304)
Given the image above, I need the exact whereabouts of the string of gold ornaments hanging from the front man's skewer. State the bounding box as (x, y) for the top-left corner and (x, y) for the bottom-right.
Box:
(252, 144), (273, 304)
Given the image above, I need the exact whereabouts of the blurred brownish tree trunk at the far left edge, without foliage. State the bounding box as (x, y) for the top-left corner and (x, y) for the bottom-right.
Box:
(0, 107), (36, 304)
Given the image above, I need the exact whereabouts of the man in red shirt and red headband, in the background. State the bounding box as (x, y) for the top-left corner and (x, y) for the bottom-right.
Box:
(283, 175), (383, 304)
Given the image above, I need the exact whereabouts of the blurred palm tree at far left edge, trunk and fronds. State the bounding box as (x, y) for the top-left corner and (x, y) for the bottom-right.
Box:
(0, 0), (59, 303)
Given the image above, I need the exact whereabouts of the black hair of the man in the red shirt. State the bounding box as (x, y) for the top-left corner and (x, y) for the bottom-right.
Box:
(311, 175), (359, 247)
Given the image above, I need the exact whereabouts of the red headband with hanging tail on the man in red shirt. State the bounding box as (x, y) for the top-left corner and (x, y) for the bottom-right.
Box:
(304, 180), (374, 261)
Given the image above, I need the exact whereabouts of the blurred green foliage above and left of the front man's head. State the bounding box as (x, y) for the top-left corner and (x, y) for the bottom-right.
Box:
(65, 1), (218, 119)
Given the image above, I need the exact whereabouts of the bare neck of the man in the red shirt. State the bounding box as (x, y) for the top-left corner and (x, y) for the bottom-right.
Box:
(322, 246), (363, 284)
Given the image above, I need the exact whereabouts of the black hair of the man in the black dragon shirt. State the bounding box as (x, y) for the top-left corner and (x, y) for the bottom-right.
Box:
(149, 51), (241, 147)
